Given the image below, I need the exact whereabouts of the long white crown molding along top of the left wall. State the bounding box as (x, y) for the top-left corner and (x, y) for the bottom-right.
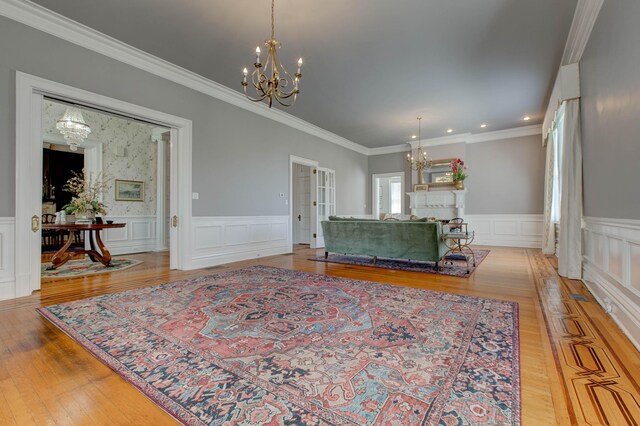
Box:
(0, 0), (369, 155)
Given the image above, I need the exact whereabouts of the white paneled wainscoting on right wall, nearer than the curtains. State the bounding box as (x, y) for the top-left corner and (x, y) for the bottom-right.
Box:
(582, 217), (640, 350)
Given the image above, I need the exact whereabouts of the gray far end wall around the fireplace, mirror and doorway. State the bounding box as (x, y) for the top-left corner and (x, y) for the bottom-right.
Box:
(369, 135), (545, 214)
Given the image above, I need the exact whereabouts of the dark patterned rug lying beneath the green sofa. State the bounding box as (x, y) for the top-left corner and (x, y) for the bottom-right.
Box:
(309, 249), (489, 278)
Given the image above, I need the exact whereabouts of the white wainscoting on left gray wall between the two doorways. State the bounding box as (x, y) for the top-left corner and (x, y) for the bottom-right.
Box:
(191, 216), (291, 268)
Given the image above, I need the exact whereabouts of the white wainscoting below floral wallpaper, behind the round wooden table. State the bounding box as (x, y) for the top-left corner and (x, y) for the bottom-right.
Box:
(101, 215), (158, 255)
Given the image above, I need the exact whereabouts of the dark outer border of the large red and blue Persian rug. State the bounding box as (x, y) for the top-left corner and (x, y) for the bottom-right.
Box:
(36, 265), (522, 425)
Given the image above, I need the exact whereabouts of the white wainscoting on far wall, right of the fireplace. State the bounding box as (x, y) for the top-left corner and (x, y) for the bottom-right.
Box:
(464, 214), (543, 248)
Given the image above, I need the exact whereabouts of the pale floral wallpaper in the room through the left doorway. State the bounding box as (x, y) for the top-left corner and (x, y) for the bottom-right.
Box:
(42, 99), (157, 216)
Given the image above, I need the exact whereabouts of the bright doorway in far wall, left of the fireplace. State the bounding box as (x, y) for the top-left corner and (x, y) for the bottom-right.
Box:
(371, 172), (404, 219)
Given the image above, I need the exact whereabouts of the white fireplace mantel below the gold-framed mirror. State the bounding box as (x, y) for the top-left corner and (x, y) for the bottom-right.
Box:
(407, 189), (467, 219)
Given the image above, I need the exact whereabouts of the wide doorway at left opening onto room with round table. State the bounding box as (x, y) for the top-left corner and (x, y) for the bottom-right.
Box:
(42, 97), (170, 280)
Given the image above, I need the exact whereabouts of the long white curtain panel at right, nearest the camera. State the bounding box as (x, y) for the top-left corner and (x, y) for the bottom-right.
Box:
(557, 99), (582, 279)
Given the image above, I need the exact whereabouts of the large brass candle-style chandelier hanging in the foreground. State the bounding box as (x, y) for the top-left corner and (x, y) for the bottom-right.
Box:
(242, 0), (302, 108)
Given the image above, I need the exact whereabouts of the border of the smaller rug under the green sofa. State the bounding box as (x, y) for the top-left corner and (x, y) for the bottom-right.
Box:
(308, 249), (491, 278)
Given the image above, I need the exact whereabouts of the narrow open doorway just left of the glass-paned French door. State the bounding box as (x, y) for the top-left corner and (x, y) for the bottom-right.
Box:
(291, 164), (311, 245)
